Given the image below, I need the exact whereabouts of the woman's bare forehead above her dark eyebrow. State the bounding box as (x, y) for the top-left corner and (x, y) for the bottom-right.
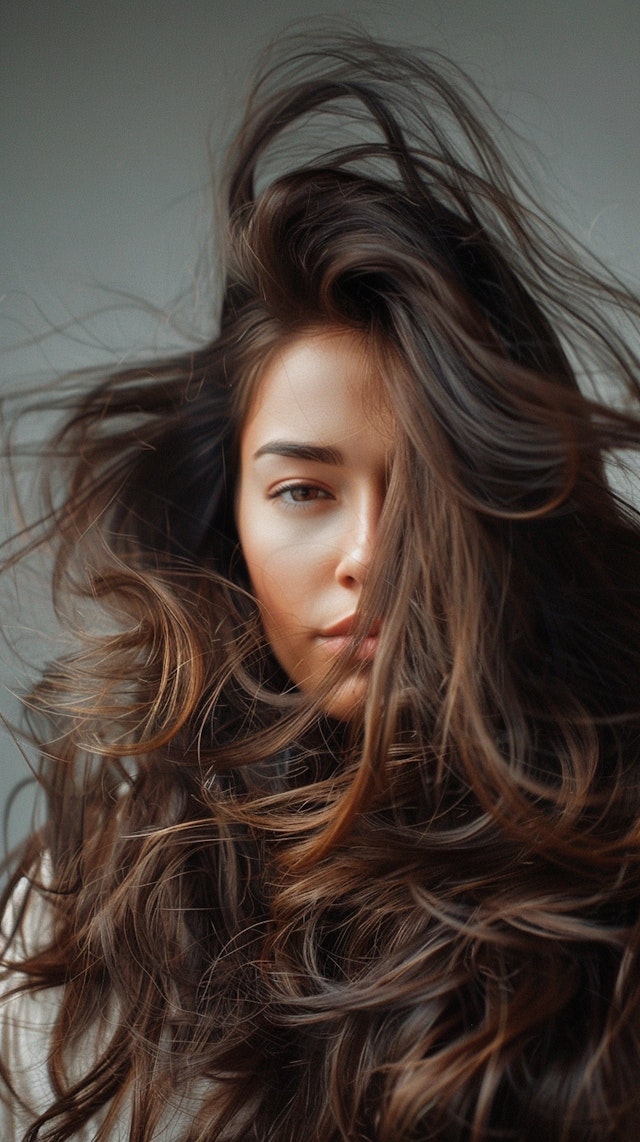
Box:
(241, 330), (393, 443)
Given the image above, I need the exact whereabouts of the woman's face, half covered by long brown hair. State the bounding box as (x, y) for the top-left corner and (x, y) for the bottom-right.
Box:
(237, 330), (393, 718)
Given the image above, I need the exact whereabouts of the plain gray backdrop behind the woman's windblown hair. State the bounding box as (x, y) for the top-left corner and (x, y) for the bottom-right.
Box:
(0, 0), (640, 858)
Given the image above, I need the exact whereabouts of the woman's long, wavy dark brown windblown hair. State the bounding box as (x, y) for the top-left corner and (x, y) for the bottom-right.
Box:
(5, 37), (640, 1142)
